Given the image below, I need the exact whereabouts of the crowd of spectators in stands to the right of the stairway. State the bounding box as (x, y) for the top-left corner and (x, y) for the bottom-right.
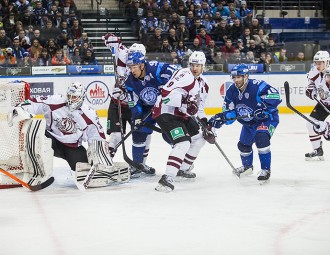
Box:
(125, 0), (312, 70)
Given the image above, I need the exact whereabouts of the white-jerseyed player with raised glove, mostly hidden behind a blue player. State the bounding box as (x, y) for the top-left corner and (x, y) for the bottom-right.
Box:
(102, 33), (149, 158)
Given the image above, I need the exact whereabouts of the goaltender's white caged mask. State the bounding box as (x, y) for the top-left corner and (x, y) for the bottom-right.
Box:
(67, 82), (86, 112)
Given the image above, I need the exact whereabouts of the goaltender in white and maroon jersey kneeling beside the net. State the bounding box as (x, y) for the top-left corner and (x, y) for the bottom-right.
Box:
(10, 82), (128, 186)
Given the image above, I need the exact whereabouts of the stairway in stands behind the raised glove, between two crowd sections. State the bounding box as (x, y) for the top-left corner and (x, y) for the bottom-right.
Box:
(81, 9), (139, 64)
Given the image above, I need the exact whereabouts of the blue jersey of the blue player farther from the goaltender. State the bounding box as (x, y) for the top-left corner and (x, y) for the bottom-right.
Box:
(222, 79), (282, 125)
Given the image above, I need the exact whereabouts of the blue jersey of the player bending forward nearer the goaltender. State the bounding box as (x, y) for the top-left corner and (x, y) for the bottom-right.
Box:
(125, 61), (177, 119)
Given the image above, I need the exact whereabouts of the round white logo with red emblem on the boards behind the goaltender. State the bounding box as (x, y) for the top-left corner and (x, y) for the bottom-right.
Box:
(86, 81), (109, 105)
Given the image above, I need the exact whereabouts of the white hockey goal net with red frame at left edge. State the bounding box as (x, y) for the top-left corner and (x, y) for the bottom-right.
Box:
(0, 81), (30, 188)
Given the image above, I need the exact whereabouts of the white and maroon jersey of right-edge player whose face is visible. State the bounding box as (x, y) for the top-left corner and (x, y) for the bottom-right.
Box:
(307, 67), (330, 107)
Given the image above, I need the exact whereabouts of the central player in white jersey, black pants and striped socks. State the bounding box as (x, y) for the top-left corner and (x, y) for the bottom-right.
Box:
(153, 51), (214, 192)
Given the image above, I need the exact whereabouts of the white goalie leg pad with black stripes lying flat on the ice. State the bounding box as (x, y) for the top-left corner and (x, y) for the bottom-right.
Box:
(75, 162), (130, 188)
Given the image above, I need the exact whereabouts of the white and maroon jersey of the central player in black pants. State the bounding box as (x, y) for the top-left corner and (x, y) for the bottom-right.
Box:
(153, 67), (209, 119)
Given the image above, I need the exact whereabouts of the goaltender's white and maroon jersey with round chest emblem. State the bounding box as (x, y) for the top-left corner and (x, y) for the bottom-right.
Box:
(21, 95), (105, 147)
